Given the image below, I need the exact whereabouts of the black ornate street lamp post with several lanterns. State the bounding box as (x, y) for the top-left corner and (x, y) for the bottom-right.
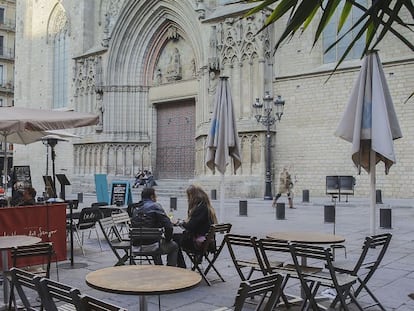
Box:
(253, 91), (285, 200)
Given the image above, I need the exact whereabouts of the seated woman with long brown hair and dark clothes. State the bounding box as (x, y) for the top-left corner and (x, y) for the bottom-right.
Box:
(177, 185), (217, 267)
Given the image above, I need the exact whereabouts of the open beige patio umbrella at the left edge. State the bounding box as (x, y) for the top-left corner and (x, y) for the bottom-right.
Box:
(0, 107), (99, 194)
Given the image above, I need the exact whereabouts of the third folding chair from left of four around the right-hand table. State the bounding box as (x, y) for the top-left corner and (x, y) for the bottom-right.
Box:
(290, 243), (363, 311)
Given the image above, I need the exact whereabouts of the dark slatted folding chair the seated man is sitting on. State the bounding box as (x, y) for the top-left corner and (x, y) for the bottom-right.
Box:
(129, 227), (164, 265)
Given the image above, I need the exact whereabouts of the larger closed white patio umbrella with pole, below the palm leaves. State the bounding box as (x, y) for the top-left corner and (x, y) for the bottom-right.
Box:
(335, 51), (402, 234)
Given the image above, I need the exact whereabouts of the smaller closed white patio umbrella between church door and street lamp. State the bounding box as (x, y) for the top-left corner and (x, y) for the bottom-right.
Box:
(206, 77), (241, 221)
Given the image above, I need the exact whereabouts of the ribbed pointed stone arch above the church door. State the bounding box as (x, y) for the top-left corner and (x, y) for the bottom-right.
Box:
(107, 0), (207, 87)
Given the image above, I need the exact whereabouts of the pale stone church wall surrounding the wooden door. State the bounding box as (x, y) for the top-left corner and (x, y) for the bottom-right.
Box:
(14, 0), (414, 198)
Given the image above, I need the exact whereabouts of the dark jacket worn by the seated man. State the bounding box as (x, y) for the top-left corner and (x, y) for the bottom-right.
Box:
(131, 199), (173, 244)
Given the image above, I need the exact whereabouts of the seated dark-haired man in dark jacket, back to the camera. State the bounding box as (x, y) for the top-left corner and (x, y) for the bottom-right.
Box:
(131, 188), (178, 266)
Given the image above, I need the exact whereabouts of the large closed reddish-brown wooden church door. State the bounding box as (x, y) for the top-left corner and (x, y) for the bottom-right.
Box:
(155, 100), (195, 179)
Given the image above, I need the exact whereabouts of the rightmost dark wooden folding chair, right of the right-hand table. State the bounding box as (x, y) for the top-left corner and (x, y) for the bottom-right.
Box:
(333, 233), (392, 311)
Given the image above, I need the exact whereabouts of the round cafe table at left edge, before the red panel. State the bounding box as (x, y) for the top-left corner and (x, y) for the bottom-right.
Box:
(0, 235), (42, 310)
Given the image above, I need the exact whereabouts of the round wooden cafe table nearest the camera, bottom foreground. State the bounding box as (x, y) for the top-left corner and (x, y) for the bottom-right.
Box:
(86, 265), (201, 311)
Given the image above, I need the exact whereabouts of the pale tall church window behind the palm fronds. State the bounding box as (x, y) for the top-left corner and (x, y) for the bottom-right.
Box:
(322, 0), (367, 64)
